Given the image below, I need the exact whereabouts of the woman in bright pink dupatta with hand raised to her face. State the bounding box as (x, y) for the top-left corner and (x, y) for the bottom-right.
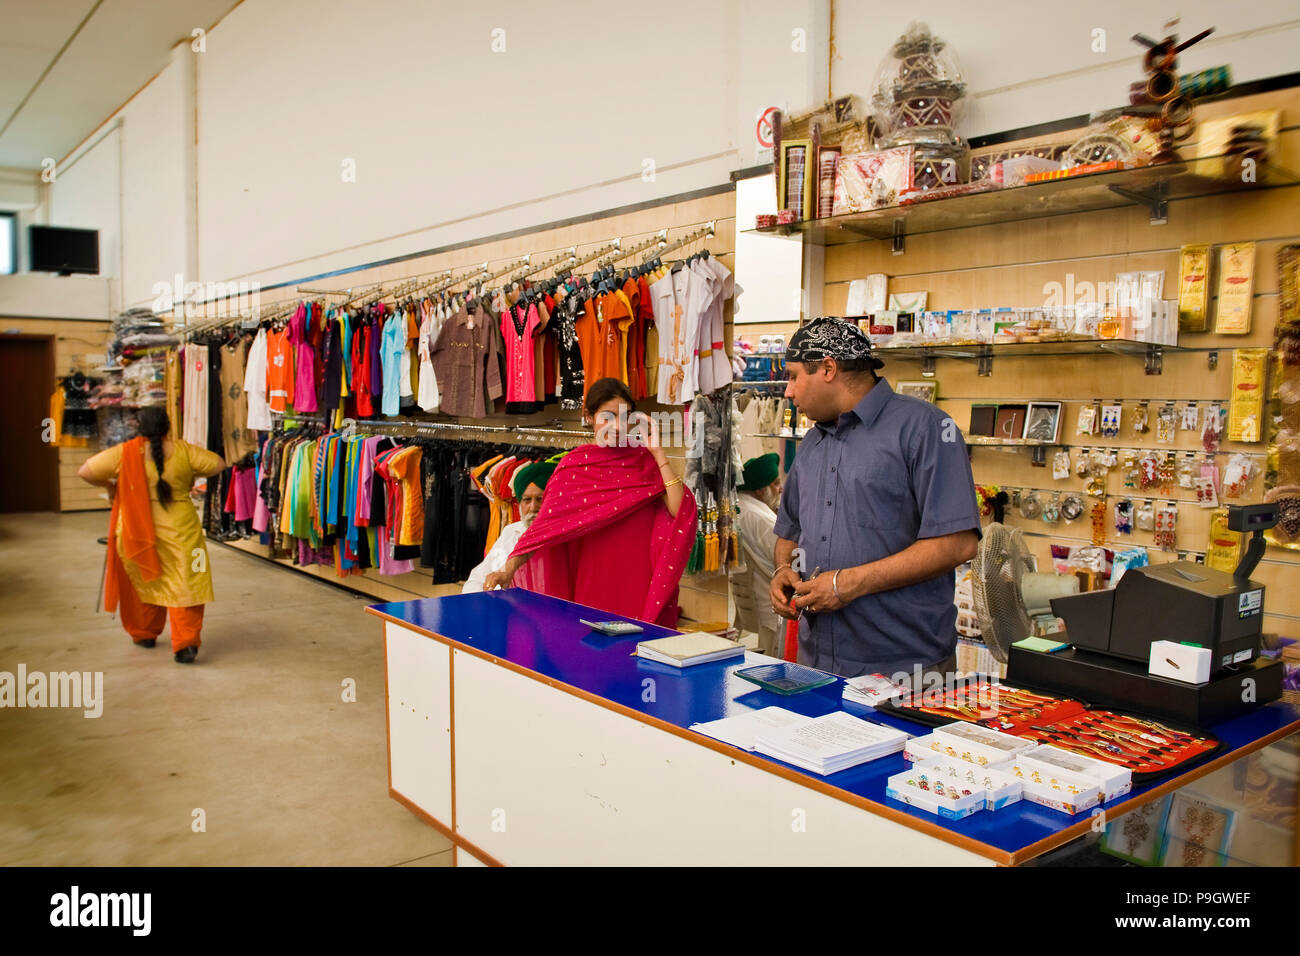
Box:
(484, 378), (696, 627)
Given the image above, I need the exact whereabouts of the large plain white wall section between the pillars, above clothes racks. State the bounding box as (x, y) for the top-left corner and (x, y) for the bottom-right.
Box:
(191, 0), (776, 287)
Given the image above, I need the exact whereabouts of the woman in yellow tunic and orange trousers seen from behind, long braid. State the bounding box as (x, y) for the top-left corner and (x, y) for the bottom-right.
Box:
(78, 407), (226, 663)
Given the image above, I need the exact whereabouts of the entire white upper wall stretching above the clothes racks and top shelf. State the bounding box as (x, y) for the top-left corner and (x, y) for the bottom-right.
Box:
(35, 0), (1300, 307)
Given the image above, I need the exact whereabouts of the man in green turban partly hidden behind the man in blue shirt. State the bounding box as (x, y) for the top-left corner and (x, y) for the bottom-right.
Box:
(732, 451), (784, 657)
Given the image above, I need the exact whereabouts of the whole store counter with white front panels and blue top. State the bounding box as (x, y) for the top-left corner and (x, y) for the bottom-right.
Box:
(367, 588), (1300, 866)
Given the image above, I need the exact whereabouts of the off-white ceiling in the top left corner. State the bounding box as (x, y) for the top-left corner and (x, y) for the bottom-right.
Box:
(0, 0), (238, 169)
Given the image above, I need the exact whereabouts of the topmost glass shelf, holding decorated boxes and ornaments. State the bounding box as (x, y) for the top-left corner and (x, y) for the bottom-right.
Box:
(741, 156), (1300, 252)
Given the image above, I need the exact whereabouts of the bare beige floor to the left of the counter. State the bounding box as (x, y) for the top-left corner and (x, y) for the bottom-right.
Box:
(0, 512), (451, 866)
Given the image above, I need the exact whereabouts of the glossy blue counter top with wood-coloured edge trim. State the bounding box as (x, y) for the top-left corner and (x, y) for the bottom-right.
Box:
(368, 588), (1300, 862)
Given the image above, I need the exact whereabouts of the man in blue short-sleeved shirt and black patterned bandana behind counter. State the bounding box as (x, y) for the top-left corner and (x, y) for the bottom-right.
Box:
(770, 319), (980, 689)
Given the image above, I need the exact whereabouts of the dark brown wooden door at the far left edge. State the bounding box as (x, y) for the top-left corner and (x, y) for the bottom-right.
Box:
(0, 336), (59, 512)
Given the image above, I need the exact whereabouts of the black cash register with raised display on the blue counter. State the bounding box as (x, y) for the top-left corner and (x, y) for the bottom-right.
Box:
(1008, 505), (1282, 726)
